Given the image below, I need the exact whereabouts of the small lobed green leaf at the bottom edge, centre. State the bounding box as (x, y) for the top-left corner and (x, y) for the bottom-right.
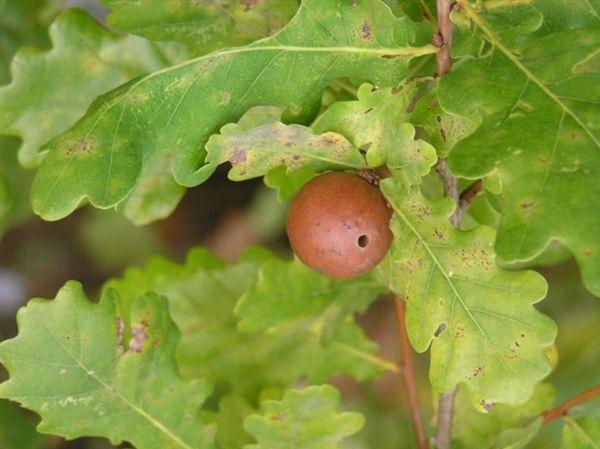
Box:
(244, 385), (364, 449)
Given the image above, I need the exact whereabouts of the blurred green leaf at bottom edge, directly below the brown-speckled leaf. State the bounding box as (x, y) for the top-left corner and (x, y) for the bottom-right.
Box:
(452, 383), (555, 449)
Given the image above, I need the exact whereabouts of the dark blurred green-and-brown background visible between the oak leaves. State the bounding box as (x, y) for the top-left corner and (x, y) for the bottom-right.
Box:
(0, 0), (600, 449)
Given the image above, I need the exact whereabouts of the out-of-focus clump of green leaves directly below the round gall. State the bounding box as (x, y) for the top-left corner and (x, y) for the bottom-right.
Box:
(105, 248), (395, 400)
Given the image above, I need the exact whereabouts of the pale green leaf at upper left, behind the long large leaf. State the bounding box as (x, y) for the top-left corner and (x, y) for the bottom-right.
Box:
(0, 9), (176, 167)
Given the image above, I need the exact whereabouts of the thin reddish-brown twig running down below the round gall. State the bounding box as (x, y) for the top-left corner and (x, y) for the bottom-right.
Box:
(394, 296), (429, 449)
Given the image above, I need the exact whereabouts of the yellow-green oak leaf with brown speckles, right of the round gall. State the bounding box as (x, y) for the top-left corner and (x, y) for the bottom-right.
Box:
(381, 174), (556, 411)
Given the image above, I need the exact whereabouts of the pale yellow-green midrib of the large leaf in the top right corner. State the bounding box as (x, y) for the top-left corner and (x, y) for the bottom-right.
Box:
(463, 2), (600, 149)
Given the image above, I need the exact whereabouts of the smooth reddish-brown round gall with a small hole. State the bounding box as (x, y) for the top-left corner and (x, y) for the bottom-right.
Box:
(287, 172), (392, 278)
